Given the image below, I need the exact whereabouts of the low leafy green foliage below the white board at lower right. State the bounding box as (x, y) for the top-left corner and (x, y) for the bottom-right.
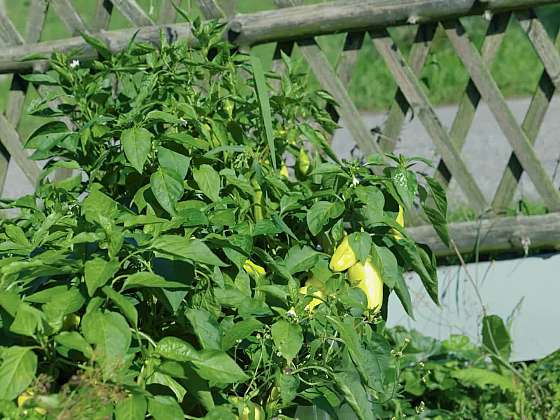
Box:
(386, 328), (560, 420)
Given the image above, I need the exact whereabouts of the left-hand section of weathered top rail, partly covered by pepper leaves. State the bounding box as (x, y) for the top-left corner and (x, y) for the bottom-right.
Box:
(0, 23), (195, 73)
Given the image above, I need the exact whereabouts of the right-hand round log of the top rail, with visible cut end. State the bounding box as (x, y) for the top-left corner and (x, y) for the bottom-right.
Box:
(228, 0), (556, 45)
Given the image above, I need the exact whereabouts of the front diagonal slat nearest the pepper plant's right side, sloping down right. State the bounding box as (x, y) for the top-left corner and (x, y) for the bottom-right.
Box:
(298, 40), (381, 155)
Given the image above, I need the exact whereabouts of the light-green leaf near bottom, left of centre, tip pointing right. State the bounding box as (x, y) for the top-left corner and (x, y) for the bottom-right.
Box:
(192, 350), (249, 384)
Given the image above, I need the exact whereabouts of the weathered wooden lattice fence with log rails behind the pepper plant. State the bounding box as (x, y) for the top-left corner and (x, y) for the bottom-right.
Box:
(0, 0), (560, 255)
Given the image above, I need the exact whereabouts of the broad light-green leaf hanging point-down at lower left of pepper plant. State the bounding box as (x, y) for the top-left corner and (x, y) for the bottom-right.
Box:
(82, 310), (132, 376)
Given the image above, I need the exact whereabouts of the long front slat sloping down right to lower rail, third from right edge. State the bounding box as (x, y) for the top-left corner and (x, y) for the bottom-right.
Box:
(371, 30), (486, 212)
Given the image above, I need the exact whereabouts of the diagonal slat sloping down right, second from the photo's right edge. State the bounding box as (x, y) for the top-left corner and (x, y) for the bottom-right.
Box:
(443, 19), (560, 210)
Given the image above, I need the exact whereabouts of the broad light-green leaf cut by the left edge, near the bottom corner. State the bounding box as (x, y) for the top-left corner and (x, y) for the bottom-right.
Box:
(0, 346), (37, 400)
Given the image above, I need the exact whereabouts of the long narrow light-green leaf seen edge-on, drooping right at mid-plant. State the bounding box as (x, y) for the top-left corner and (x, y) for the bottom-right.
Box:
(151, 235), (226, 267)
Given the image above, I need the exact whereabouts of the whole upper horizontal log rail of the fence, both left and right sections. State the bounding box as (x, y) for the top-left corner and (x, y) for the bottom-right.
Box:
(0, 0), (559, 73)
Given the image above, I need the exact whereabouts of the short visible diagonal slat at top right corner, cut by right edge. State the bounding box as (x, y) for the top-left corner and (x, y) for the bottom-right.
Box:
(515, 9), (560, 89)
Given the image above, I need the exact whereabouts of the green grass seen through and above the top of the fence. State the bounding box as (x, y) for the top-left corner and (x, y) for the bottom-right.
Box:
(0, 0), (560, 118)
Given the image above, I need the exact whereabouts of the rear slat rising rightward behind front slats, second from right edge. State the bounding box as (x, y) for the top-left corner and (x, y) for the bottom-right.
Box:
(435, 13), (511, 186)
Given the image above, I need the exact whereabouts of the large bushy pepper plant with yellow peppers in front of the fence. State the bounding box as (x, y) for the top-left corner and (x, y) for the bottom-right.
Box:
(0, 16), (447, 420)
